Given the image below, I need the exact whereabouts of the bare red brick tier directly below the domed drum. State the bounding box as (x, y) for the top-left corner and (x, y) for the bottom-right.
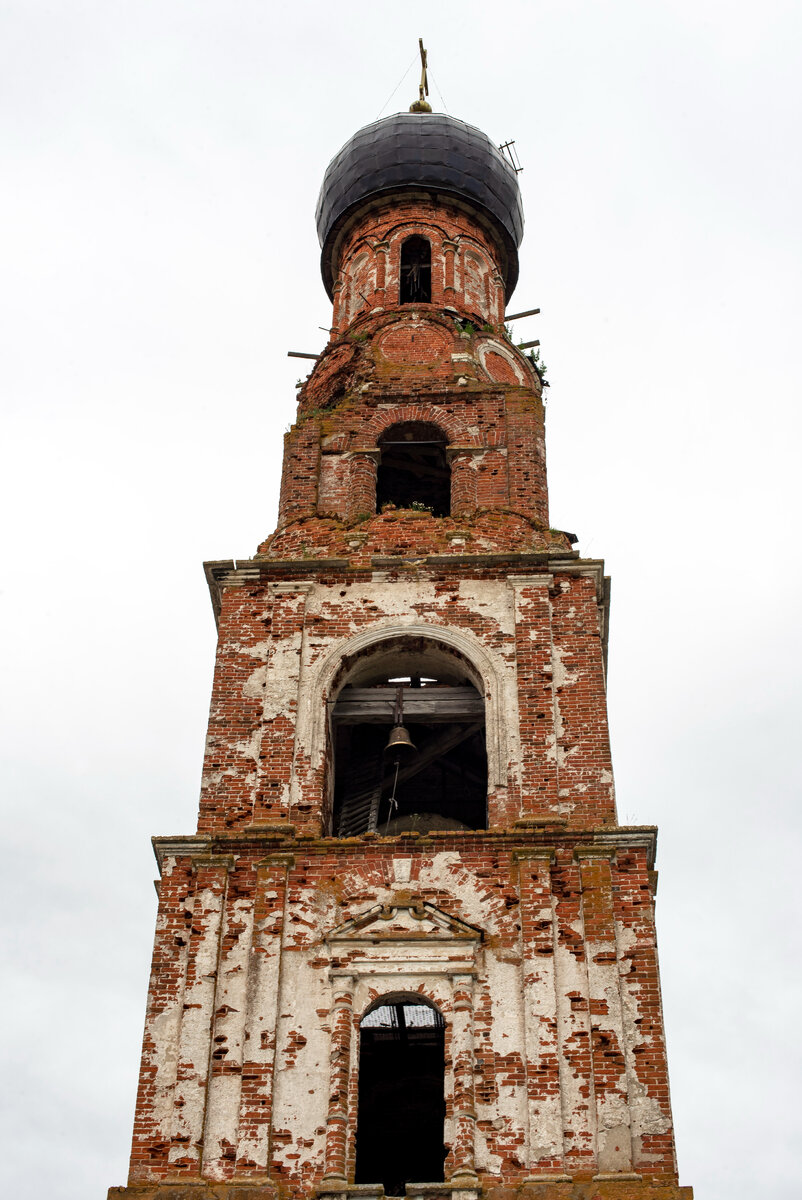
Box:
(268, 305), (552, 557)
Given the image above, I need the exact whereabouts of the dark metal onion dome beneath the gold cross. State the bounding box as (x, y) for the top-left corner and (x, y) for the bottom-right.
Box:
(316, 113), (523, 299)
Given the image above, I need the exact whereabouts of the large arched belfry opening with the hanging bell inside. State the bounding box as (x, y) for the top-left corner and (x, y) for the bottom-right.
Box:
(331, 637), (487, 838)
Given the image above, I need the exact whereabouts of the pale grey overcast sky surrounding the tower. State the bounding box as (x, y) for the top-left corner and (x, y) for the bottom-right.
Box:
(0, 0), (802, 1200)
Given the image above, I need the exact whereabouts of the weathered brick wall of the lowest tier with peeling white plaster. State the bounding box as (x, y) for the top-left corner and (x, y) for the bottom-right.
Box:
(122, 828), (675, 1195)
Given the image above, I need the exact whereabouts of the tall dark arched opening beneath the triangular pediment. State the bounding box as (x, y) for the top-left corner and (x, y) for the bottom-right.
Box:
(355, 996), (445, 1196)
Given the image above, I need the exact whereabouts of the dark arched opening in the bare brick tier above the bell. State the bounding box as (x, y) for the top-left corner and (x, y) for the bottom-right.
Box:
(376, 421), (451, 517)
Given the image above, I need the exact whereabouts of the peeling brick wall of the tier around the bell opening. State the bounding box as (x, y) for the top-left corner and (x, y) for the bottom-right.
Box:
(192, 566), (615, 833)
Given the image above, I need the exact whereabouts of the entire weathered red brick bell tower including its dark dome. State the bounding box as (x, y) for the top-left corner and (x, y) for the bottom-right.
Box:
(109, 100), (692, 1200)
